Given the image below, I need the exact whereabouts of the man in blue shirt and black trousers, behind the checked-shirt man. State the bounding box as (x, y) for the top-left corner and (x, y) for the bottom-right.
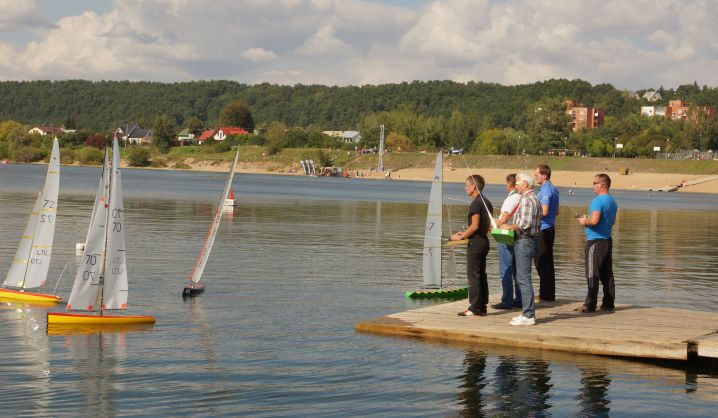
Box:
(534, 164), (559, 302)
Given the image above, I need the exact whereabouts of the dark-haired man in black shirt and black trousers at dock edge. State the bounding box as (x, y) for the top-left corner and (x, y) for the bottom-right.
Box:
(451, 174), (494, 316)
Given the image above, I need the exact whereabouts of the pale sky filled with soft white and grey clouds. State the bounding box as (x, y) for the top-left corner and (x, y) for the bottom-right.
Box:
(0, 0), (718, 90)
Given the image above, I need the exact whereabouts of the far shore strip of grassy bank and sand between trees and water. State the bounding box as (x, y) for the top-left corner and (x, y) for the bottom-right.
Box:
(11, 145), (718, 193)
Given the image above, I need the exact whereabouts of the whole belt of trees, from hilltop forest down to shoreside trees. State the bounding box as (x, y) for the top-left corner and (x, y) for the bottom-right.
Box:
(0, 79), (718, 160)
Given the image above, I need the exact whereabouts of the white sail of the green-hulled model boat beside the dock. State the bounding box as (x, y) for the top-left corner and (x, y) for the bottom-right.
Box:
(424, 152), (444, 289)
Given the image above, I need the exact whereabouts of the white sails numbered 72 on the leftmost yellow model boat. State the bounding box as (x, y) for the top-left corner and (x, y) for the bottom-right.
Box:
(5, 138), (60, 289)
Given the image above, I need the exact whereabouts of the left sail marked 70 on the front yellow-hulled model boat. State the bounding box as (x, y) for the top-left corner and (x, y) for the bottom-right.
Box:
(67, 148), (110, 311)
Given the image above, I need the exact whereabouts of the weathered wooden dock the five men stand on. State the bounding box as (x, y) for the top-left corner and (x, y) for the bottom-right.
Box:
(355, 300), (718, 360)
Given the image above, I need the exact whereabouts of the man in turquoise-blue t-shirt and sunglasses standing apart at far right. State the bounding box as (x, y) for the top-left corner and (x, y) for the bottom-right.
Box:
(576, 174), (618, 313)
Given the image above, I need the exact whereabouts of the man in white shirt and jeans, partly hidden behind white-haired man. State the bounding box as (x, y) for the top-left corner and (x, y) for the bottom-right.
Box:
(491, 174), (521, 309)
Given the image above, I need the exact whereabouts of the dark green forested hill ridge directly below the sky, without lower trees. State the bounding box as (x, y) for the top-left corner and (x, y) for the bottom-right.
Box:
(0, 80), (718, 130)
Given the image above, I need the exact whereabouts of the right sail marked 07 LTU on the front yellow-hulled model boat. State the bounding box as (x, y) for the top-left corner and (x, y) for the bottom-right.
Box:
(102, 138), (127, 309)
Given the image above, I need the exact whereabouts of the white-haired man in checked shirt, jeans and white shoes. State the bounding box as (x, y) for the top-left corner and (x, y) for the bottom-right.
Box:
(501, 173), (541, 325)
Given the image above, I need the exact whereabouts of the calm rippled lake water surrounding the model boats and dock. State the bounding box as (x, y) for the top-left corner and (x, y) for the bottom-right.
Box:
(0, 165), (718, 417)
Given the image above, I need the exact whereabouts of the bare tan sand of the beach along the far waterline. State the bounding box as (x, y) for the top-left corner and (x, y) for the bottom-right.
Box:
(179, 160), (718, 193)
